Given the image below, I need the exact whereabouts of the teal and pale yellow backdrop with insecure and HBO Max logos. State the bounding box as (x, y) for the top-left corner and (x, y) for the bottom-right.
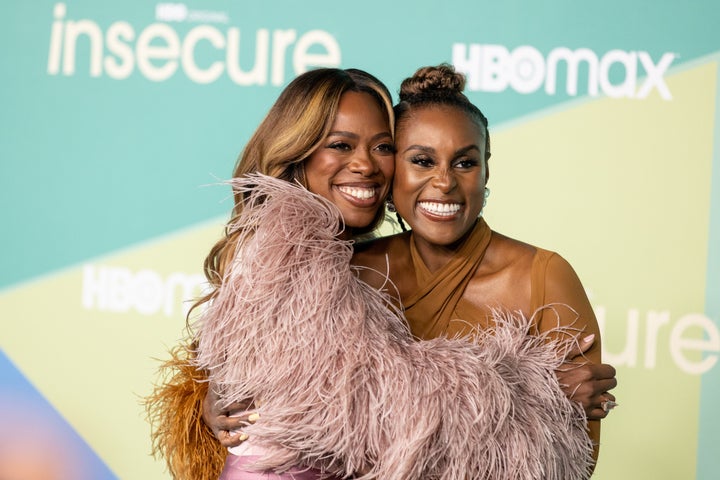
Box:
(0, 0), (720, 480)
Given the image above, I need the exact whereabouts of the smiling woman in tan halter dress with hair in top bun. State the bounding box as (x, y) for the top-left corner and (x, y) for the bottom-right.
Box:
(149, 67), (614, 476)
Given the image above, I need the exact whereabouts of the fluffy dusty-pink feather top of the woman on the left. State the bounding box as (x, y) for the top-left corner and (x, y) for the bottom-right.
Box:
(191, 175), (592, 480)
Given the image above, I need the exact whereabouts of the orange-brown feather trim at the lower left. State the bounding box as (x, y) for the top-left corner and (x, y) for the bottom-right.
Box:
(144, 346), (227, 480)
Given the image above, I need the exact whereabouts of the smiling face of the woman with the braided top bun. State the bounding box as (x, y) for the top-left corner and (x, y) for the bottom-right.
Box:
(393, 106), (488, 247)
